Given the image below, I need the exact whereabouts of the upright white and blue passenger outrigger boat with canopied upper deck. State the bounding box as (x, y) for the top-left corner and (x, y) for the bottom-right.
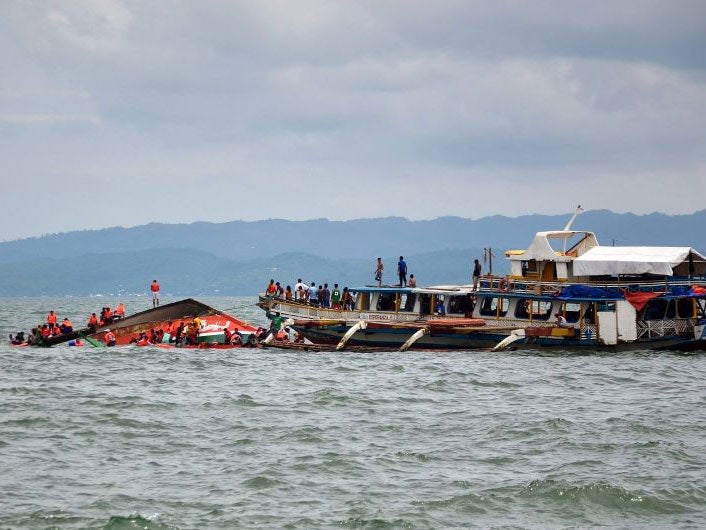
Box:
(258, 212), (706, 350)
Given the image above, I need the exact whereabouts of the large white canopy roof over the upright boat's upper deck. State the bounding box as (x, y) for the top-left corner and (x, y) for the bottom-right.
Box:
(574, 246), (706, 276)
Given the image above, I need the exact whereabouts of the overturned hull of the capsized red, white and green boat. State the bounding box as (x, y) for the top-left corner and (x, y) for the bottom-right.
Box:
(88, 298), (258, 348)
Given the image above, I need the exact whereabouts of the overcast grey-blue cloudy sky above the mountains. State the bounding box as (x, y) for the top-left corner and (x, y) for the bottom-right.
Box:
(0, 0), (706, 240)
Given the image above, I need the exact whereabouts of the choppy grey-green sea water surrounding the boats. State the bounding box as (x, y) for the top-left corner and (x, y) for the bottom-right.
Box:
(0, 297), (706, 529)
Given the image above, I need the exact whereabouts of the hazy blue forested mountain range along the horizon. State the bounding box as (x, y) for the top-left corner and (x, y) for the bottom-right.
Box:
(0, 210), (706, 296)
